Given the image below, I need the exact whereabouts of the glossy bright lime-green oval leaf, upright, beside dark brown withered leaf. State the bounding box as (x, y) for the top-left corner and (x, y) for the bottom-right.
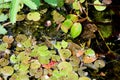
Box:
(70, 23), (82, 38)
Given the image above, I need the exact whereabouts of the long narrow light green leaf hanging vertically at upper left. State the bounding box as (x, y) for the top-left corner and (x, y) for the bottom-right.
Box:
(10, 0), (20, 24)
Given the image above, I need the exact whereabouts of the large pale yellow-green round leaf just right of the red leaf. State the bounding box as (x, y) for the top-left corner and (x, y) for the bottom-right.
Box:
(58, 62), (73, 75)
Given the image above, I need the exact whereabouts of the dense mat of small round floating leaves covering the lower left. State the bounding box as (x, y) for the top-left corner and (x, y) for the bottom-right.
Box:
(0, 34), (105, 80)
